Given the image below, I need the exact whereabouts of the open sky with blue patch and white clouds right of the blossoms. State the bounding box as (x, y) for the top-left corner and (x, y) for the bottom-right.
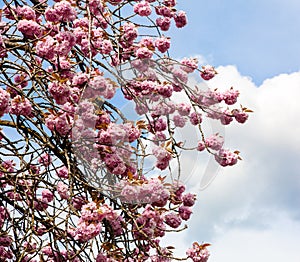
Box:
(163, 0), (300, 262)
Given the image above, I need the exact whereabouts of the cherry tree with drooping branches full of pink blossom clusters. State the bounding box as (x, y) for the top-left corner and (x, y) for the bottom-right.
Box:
(0, 0), (251, 262)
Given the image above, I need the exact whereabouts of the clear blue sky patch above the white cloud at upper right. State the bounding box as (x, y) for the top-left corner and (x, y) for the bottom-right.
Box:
(173, 0), (300, 84)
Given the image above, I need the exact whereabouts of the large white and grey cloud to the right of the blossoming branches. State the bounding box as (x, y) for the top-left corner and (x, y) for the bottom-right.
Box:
(162, 66), (300, 262)
